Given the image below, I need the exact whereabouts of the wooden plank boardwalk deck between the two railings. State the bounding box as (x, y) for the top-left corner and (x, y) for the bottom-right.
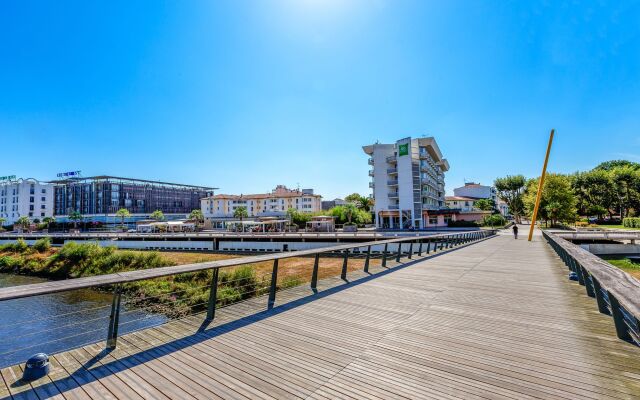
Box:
(0, 236), (640, 399)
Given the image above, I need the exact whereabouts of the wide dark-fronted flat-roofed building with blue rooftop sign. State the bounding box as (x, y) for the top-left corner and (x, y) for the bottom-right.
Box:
(51, 175), (216, 224)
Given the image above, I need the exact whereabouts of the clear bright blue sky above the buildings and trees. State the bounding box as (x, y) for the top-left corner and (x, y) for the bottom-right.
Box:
(0, 0), (640, 198)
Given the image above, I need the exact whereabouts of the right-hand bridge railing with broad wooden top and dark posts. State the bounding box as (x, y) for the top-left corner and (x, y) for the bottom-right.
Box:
(542, 231), (640, 346)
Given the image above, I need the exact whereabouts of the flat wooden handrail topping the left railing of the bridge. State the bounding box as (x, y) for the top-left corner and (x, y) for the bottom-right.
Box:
(0, 231), (495, 301)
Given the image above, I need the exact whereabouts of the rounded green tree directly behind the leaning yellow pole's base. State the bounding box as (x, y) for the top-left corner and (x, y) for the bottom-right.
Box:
(524, 173), (578, 226)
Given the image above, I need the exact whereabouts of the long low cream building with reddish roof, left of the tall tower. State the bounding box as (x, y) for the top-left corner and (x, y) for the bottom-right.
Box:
(200, 185), (322, 228)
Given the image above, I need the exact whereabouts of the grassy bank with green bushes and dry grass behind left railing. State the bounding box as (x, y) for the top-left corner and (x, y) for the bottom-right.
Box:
(0, 239), (370, 316)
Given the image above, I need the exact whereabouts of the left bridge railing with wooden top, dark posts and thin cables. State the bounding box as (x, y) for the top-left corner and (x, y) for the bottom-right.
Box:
(0, 230), (495, 355)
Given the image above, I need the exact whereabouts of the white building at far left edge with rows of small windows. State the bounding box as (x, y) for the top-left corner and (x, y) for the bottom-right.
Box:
(0, 177), (54, 225)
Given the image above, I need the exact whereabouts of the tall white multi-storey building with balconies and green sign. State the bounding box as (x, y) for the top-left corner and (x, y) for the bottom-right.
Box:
(363, 137), (452, 229)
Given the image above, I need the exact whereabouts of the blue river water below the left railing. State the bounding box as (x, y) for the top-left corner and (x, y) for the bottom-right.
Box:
(0, 273), (166, 368)
